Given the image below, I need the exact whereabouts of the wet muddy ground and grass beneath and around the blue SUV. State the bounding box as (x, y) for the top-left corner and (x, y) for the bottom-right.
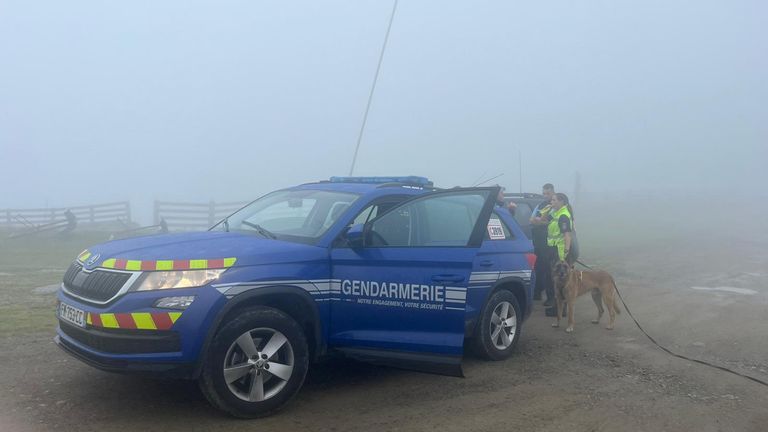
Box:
(0, 213), (768, 432)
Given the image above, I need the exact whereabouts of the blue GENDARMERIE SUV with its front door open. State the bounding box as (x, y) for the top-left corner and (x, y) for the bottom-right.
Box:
(55, 177), (535, 417)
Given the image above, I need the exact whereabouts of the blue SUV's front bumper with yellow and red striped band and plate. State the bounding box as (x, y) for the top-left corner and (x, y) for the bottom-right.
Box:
(54, 287), (226, 378)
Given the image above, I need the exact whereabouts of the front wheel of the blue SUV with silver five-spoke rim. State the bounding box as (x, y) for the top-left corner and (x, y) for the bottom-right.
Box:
(200, 306), (309, 418)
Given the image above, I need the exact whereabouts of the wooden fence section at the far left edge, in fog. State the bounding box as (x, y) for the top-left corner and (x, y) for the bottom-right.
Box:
(0, 201), (131, 228)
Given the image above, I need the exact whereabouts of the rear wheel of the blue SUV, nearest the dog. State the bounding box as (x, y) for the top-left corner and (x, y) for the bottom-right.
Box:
(474, 290), (523, 361)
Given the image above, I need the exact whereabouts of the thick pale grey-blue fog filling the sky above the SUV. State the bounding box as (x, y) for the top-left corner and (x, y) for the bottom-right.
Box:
(0, 0), (768, 220)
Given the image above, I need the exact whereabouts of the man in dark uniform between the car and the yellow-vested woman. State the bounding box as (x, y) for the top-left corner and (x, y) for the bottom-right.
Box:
(530, 183), (555, 307)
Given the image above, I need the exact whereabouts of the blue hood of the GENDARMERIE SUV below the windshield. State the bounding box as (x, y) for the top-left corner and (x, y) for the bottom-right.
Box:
(79, 231), (325, 269)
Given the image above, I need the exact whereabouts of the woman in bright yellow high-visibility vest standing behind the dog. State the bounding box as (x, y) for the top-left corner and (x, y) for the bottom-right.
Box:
(544, 193), (577, 316)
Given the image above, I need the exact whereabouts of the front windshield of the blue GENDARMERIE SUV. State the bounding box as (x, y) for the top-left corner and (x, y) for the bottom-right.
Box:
(211, 189), (359, 241)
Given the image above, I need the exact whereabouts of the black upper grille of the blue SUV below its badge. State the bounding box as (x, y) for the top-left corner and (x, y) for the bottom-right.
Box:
(64, 263), (131, 302)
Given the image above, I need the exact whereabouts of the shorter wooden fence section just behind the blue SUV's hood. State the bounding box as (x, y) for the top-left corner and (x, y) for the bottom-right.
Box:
(154, 200), (248, 231)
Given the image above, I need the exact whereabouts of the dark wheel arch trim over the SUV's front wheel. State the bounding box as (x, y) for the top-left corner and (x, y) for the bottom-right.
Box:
(193, 285), (325, 378)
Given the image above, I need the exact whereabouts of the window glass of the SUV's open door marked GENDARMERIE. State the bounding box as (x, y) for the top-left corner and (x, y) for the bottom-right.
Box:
(369, 191), (488, 247)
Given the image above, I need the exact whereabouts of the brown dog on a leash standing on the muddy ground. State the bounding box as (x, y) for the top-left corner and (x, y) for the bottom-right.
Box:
(552, 261), (621, 333)
